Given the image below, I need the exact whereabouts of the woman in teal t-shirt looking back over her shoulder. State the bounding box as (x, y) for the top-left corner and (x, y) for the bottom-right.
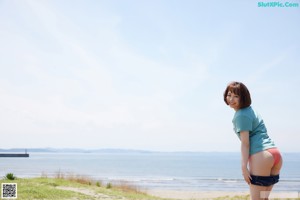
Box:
(224, 82), (282, 200)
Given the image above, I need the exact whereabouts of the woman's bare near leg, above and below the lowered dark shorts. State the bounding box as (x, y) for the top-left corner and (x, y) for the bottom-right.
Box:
(249, 151), (274, 200)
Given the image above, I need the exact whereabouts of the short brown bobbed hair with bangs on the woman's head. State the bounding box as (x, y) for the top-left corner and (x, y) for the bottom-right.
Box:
(224, 82), (251, 108)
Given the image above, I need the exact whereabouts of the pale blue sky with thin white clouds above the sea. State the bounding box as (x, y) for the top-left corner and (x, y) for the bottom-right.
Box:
(0, 0), (300, 152)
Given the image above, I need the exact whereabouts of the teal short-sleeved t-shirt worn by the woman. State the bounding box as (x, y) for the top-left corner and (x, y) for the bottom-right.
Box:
(232, 106), (276, 155)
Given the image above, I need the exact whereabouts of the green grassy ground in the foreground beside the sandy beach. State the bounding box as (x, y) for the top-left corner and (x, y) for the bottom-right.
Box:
(0, 175), (296, 200)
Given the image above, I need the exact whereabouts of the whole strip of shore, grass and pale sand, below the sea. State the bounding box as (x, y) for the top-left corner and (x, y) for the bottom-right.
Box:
(0, 177), (300, 200)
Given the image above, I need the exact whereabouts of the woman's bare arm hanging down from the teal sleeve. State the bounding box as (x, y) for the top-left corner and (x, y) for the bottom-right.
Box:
(240, 131), (251, 184)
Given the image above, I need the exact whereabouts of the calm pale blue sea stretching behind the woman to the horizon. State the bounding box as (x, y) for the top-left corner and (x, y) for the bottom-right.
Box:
(0, 153), (300, 191)
